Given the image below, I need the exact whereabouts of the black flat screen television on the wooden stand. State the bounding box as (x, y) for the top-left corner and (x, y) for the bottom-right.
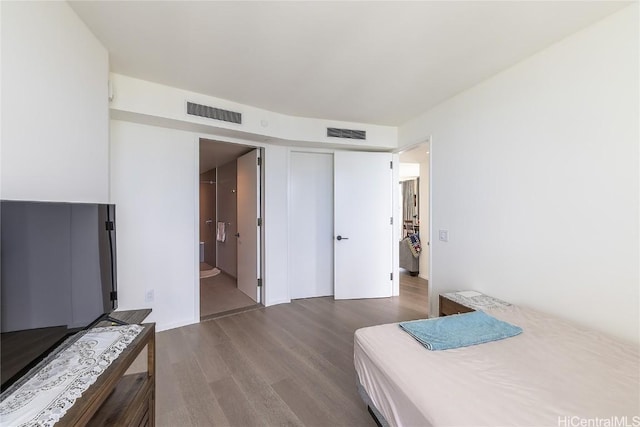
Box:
(0, 200), (117, 391)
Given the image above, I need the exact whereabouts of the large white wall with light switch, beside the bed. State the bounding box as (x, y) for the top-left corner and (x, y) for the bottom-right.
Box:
(400, 4), (640, 341)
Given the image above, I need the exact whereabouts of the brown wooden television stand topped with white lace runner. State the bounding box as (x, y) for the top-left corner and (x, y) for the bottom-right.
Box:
(2, 310), (156, 427)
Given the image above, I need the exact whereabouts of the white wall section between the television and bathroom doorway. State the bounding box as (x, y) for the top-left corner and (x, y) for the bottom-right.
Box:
(111, 120), (199, 330)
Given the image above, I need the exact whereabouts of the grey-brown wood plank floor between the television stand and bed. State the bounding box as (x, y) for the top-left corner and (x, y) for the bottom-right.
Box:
(156, 274), (428, 427)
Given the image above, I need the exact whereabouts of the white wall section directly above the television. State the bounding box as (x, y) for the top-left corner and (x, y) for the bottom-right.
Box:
(0, 2), (109, 202)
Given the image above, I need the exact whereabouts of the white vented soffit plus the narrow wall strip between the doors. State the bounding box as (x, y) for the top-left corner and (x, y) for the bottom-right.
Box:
(105, 74), (397, 314)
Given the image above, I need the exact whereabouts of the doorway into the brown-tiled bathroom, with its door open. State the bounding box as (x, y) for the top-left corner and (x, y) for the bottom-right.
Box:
(199, 138), (262, 320)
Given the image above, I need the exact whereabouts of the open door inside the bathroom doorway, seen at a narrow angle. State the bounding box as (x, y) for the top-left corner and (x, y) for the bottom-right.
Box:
(237, 150), (260, 302)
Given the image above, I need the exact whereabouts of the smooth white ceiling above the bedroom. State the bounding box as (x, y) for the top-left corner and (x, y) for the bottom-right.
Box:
(70, 0), (628, 126)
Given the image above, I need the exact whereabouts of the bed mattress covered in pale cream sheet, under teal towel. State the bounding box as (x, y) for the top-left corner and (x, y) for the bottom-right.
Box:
(354, 306), (640, 427)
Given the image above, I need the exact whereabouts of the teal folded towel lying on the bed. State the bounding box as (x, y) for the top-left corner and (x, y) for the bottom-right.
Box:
(400, 311), (522, 350)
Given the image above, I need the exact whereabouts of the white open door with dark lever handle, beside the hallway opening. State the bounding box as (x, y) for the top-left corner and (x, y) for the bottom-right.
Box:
(334, 152), (393, 299)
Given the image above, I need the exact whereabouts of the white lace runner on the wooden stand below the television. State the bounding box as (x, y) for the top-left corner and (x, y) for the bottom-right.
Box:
(0, 325), (143, 427)
